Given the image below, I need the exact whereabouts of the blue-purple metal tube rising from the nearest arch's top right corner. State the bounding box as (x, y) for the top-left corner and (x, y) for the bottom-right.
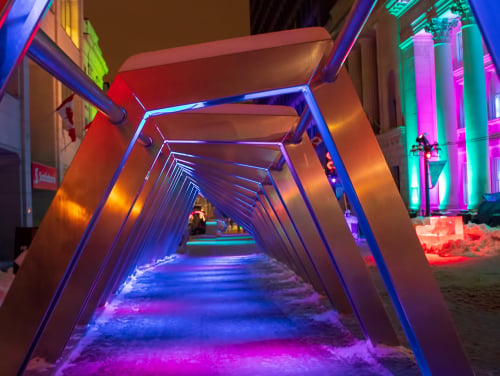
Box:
(323, 0), (377, 82)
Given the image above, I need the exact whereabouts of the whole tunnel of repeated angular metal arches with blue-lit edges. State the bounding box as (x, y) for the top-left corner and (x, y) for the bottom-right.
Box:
(0, 1), (500, 375)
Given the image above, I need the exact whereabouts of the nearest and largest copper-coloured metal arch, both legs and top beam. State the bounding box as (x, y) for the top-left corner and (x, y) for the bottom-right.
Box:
(0, 29), (471, 375)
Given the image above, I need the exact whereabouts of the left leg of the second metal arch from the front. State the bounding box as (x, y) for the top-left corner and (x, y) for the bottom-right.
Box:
(33, 117), (166, 362)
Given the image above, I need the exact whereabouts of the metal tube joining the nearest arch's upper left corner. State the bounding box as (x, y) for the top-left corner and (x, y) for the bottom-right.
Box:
(27, 29), (127, 124)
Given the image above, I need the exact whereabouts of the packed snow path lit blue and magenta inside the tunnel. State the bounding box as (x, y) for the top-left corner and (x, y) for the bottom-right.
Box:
(49, 254), (419, 376)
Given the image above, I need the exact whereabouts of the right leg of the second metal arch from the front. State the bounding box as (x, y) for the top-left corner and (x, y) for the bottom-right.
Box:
(284, 137), (399, 346)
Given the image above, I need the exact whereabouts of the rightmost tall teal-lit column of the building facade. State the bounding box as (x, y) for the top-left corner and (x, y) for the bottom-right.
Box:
(452, 0), (489, 209)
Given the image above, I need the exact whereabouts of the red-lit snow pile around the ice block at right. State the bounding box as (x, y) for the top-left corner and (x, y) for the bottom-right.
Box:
(413, 218), (500, 257)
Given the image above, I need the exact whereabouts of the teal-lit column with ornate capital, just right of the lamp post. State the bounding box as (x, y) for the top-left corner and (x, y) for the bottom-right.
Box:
(426, 18), (460, 209)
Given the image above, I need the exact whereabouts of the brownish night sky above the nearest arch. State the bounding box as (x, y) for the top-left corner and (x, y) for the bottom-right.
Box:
(84, 0), (250, 82)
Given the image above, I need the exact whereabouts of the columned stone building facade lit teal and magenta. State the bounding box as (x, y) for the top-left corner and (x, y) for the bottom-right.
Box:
(327, 0), (500, 212)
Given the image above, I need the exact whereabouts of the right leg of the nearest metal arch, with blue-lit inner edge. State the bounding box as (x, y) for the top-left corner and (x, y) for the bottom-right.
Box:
(306, 70), (473, 375)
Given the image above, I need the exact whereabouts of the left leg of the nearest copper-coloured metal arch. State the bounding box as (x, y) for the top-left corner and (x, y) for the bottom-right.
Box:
(0, 78), (146, 375)
